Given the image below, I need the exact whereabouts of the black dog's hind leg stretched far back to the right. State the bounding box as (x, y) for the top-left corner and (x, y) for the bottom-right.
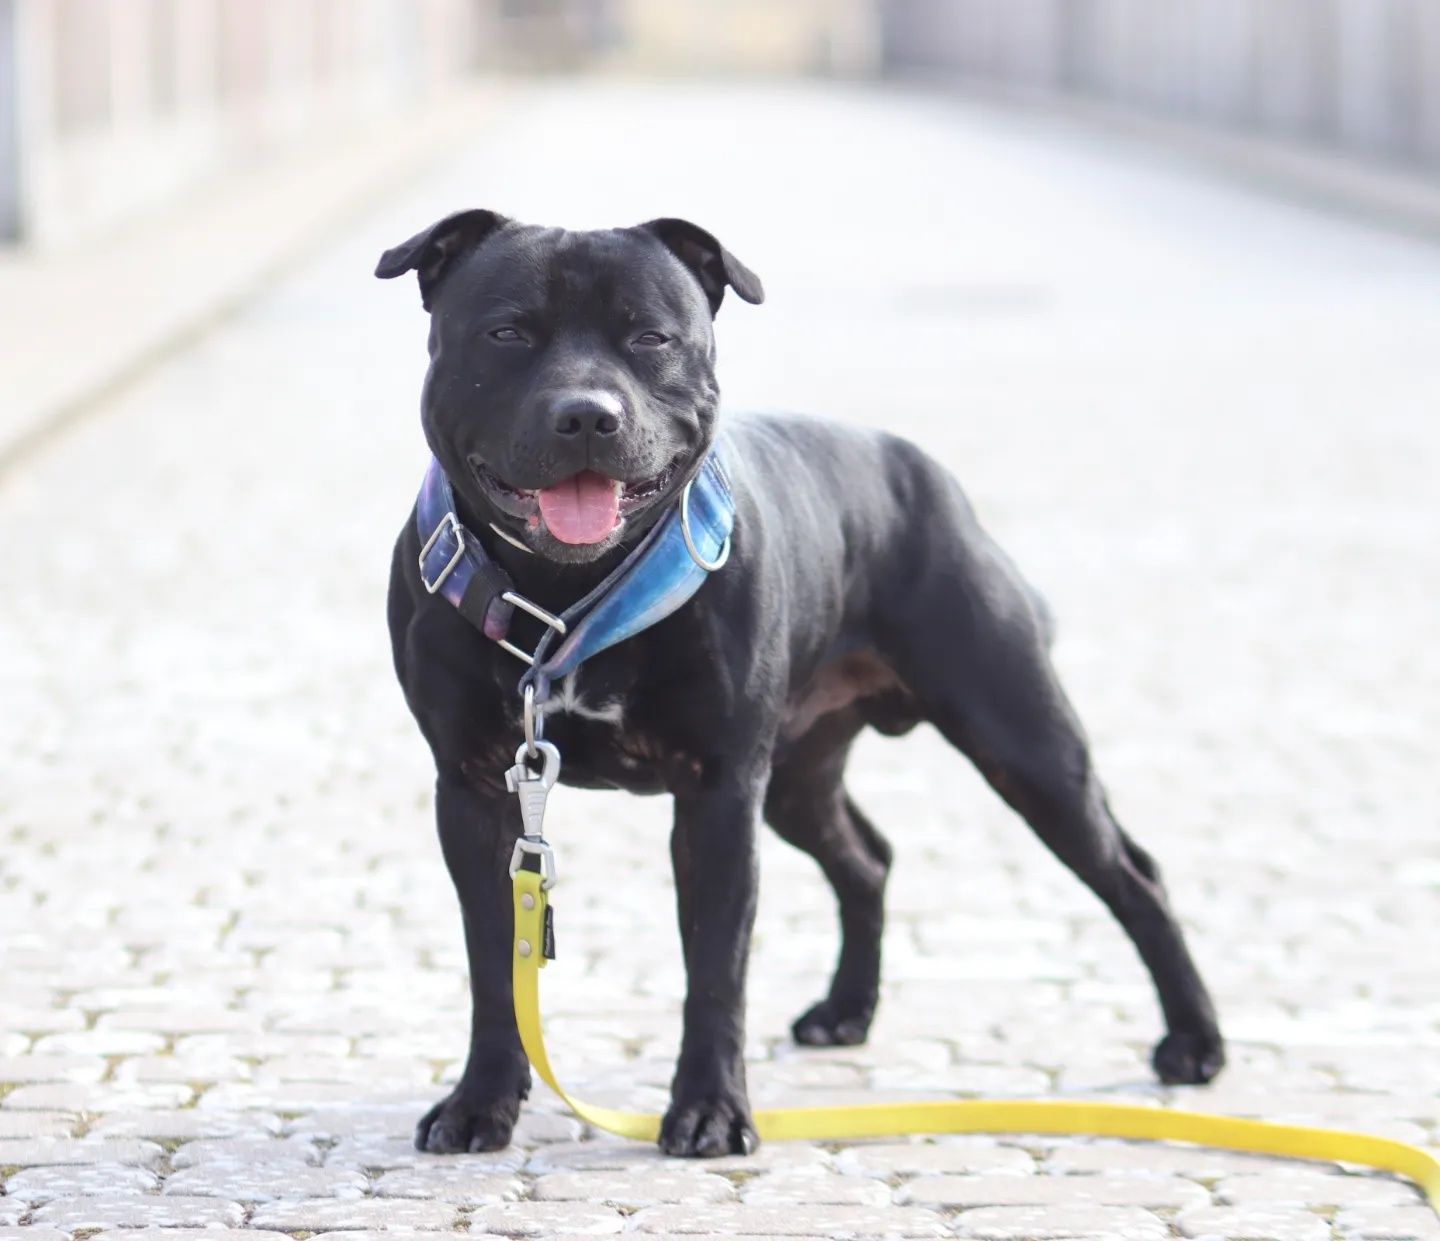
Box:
(887, 472), (1224, 1083)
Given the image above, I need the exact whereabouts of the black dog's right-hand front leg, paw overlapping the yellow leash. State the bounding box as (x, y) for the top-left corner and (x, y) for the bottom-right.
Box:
(660, 772), (765, 1156)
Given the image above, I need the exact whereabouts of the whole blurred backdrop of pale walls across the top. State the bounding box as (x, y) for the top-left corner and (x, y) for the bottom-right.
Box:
(8, 0), (1440, 242)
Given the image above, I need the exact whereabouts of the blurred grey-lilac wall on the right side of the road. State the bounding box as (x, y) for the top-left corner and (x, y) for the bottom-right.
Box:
(878, 0), (1440, 168)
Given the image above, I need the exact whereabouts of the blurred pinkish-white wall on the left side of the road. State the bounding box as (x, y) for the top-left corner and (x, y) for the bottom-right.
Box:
(0, 0), (497, 242)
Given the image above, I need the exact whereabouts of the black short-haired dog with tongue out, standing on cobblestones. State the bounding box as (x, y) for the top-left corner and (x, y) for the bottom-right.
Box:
(376, 210), (1224, 1155)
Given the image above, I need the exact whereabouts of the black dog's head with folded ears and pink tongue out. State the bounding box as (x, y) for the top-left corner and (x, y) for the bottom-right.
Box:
(374, 210), (765, 563)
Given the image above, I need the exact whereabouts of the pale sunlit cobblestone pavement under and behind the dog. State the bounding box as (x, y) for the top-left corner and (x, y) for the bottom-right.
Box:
(0, 85), (1440, 1241)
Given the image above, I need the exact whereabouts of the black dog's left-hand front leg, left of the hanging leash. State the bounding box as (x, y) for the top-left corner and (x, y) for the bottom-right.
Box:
(415, 773), (530, 1153)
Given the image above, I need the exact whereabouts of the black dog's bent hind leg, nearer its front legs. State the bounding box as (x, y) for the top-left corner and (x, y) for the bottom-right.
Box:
(765, 707), (890, 1047)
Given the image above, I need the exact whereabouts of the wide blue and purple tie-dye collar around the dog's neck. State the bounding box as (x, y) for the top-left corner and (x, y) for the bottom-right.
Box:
(415, 448), (734, 701)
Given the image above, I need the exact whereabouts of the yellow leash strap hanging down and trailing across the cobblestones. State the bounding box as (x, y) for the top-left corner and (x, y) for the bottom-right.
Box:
(514, 870), (1440, 1214)
